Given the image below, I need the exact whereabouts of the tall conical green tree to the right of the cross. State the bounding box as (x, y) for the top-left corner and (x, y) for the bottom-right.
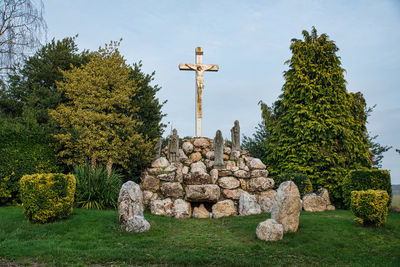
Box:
(261, 28), (372, 206)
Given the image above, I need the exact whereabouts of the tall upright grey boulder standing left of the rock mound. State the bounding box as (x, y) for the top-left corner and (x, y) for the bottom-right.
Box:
(118, 181), (143, 225)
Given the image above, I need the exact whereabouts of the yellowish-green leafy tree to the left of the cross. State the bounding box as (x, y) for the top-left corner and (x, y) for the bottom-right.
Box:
(49, 42), (152, 174)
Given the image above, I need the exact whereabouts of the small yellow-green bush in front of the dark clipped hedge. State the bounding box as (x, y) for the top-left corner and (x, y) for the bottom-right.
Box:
(350, 190), (389, 226)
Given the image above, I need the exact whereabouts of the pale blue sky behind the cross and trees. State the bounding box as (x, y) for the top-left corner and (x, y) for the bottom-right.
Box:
(44, 0), (400, 184)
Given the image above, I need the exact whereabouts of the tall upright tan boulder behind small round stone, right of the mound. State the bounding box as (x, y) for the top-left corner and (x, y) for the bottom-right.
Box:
(271, 181), (301, 233)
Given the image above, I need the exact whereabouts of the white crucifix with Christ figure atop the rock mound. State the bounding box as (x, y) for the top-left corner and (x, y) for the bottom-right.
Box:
(179, 47), (218, 137)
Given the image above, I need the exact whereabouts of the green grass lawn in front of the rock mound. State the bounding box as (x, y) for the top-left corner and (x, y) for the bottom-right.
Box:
(0, 207), (400, 266)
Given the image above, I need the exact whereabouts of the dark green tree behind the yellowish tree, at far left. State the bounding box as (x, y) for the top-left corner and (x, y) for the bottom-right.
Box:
(0, 36), (90, 126)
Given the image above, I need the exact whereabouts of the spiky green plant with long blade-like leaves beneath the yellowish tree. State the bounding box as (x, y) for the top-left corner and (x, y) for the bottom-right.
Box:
(74, 166), (123, 209)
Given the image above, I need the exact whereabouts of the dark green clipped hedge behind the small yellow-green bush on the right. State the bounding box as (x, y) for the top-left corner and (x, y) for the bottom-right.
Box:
(343, 169), (392, 207)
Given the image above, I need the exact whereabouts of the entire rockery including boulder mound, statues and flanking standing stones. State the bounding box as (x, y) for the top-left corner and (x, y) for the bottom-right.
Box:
(118, 129), (335, 238)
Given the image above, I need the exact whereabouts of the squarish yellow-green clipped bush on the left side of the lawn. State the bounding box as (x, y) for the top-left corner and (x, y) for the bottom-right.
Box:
(19, 173), (76, 223)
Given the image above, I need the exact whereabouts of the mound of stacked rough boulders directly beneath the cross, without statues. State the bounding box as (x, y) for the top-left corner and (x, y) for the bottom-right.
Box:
(140, 138), (276, 221)
